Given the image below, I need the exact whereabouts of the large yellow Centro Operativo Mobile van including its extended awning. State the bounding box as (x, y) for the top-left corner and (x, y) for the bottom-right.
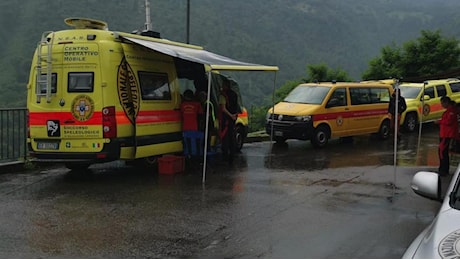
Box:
(27, 18), (277, 168)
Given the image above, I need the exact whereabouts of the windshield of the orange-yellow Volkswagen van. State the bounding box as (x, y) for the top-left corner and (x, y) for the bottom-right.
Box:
(284, 85), (330, 105)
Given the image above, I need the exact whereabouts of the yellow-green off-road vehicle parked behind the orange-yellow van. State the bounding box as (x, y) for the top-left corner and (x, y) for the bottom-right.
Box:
(399, 78), (460, 132)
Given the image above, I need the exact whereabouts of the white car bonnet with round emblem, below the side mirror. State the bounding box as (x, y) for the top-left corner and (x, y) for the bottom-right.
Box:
(404, 204), (460, 259)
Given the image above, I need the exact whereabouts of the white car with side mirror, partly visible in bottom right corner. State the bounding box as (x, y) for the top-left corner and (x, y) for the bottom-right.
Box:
(402, 164), (460, 259)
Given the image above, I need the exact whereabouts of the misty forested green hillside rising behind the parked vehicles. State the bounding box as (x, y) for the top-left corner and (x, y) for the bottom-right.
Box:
(0, 0), (460, 107)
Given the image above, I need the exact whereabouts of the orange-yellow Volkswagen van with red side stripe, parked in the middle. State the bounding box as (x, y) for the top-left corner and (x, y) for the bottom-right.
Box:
(266, 82), (393, 147)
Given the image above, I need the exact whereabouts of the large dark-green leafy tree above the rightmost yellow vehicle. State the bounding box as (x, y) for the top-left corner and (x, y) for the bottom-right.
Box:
(362, 30), (460, 80)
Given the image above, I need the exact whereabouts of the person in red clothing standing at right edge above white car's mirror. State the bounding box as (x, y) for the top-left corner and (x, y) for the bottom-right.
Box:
(438, 96), (458, 176)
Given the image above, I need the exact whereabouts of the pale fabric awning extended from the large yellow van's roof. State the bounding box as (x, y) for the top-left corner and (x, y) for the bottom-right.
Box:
(122, 36), (278, 71)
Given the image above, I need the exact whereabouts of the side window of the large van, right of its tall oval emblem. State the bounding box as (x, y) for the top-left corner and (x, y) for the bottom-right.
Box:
(139, 71), (171, 100)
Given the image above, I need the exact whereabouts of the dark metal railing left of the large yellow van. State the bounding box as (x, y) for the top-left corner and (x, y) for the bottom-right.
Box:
(0, 108), (27, 163)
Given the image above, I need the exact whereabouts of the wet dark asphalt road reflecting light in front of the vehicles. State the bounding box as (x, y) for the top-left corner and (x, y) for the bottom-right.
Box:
(0, 124), (452, 258)
